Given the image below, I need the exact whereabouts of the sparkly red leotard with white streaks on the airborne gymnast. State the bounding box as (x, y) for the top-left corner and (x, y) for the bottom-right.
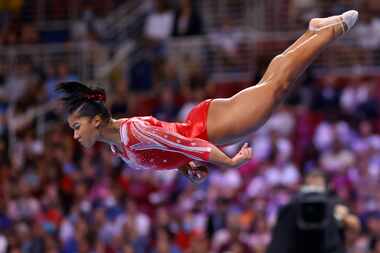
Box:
(111, 100), (211, 170)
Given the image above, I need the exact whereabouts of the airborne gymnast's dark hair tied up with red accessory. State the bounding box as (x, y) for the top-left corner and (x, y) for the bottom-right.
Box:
(56, 81), (111, 121)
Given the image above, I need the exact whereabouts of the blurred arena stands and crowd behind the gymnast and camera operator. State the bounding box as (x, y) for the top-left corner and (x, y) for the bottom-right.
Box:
(0, 0), (380, 253)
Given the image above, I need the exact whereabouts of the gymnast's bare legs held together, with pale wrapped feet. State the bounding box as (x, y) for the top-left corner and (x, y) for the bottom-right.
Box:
(207, 11), (358, 145)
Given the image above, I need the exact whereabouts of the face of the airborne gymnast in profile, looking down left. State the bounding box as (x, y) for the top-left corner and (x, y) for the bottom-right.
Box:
(67, 112), (101, 148)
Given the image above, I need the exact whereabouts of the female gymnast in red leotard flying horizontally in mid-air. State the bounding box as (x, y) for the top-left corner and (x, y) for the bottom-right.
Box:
(57, 10), (358, 182)
